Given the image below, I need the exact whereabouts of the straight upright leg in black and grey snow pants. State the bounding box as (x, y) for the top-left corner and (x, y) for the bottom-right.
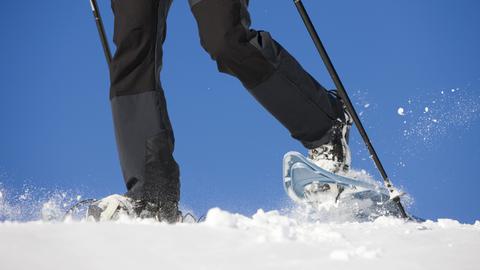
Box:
(110, 0), (180, 204)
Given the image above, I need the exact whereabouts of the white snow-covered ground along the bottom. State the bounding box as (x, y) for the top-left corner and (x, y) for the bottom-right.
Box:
(0, 208), (480, 270)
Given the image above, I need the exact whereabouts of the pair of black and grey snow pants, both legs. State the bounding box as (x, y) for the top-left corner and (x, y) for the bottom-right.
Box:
(110, 0), (343, 202)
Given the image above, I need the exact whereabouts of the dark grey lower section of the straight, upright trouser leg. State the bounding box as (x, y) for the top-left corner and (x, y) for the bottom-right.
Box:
(111, 90), (180, 202)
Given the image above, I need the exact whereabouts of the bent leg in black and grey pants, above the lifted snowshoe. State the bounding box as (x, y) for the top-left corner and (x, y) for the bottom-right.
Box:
(189, 0), (344, 149)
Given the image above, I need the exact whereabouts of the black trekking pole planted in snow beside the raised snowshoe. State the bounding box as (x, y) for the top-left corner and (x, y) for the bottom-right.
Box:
(293, 0), (410, 218)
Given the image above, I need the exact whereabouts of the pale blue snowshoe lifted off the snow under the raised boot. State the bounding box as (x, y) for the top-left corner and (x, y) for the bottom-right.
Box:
(283, 152), (406, 220)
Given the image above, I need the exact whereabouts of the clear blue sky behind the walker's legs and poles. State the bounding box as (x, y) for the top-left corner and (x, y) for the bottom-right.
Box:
(0, 0), (480, 222)
